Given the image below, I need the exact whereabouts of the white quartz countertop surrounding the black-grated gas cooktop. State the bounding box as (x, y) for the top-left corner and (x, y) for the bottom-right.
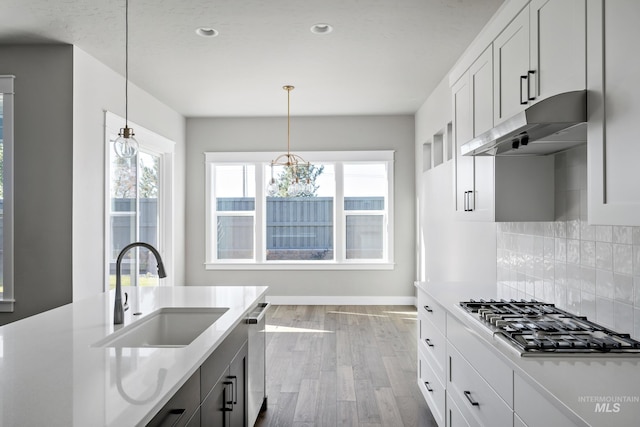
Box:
(416, 282), (640, 426)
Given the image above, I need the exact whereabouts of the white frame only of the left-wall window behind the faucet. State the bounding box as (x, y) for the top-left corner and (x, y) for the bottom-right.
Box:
(103, 111), (175, 291)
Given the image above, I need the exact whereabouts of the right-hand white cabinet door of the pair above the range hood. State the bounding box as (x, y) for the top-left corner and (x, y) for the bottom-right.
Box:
(527, 0), (586, 102)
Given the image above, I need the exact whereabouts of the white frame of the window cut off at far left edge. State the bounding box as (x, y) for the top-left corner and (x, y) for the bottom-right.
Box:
(0, 75), (15, 313)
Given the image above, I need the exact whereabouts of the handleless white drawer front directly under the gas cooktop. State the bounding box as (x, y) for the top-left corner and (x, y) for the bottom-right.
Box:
(447, 316), (513, 407)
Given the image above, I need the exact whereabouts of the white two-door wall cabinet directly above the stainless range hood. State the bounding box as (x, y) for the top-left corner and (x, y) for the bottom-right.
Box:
(493, 0), (586, 124)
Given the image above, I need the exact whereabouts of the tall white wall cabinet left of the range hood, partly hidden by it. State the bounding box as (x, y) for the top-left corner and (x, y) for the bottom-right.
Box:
(452, 46), (554, 221)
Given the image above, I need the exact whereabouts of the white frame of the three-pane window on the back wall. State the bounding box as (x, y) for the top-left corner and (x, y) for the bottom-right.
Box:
(204, 150), (395, 270)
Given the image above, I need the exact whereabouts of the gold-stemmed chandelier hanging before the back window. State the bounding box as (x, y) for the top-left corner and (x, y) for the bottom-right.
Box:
(267, 85), (314, 197)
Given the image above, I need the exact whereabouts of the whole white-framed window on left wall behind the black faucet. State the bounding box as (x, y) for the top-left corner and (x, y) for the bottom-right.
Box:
(105, 113), (174, 289)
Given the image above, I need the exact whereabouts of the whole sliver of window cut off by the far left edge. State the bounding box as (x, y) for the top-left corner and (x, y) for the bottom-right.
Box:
(0, 76), (14, 312)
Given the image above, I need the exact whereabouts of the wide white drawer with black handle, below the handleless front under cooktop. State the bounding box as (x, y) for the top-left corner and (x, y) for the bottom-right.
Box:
(447, 345), (513, 426)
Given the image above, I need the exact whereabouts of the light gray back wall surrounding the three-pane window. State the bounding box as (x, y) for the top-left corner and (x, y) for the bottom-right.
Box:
(186, 116), (415, 297)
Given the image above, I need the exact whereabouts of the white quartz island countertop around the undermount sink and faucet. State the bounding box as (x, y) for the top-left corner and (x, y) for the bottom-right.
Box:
(0, 286), (267, 427)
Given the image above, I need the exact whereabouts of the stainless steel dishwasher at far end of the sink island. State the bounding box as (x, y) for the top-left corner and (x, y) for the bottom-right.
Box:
(245, 300), (271, 426)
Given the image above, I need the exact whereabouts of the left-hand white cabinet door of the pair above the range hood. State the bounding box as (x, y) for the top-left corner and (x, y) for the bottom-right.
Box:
(493, 7), (532, 124)
